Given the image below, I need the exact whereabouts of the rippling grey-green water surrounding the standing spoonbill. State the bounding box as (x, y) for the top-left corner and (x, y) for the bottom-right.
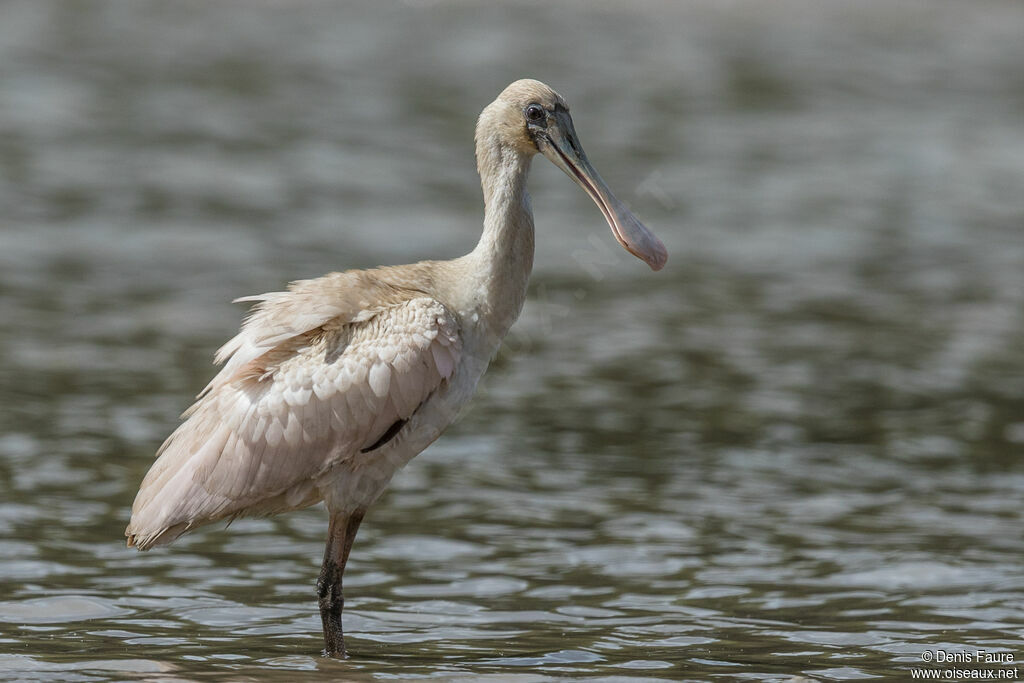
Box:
(0, 1), (1024, 683)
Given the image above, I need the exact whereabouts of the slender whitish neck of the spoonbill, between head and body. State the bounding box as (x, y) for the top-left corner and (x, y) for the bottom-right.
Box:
(469, 140), (534, 338)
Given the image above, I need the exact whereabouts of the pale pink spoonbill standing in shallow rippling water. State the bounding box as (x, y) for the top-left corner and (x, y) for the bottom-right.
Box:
(125, 79), (668, 658)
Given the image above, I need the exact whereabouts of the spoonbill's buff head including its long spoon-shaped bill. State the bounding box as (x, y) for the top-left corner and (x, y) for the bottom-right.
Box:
(477, 79), (669, 270)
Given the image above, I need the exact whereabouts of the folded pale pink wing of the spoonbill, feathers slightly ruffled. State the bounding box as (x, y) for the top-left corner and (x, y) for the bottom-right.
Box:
(126, 273), (461, 550)
